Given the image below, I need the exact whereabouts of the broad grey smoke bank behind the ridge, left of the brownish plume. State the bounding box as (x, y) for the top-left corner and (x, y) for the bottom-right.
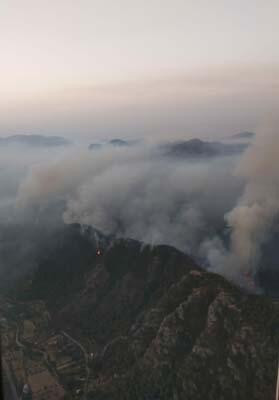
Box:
(17, 146), (245, 266)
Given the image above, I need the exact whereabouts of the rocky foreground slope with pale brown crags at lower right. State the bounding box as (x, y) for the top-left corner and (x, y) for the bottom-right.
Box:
(88, 270), (279, 400)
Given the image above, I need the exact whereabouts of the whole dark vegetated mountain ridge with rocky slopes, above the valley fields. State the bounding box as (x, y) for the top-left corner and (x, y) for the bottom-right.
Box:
(12, 226), (279, 400)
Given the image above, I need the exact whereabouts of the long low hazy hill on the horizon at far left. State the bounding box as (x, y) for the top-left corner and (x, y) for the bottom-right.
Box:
(0, 135), (71, 147)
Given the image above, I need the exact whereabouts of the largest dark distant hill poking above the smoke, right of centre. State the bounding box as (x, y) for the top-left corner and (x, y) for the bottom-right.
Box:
(162, 139), (248, 158)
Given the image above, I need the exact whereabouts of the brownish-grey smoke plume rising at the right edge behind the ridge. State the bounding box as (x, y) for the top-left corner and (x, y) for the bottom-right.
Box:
(201, 124), (279, 289)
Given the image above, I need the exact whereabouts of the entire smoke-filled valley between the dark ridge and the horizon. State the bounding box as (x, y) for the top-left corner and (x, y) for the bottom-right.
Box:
(0, 129), (279, 292)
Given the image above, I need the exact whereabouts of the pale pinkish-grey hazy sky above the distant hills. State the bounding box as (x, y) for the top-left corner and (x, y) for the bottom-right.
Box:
(0, 0), (279, 138)
